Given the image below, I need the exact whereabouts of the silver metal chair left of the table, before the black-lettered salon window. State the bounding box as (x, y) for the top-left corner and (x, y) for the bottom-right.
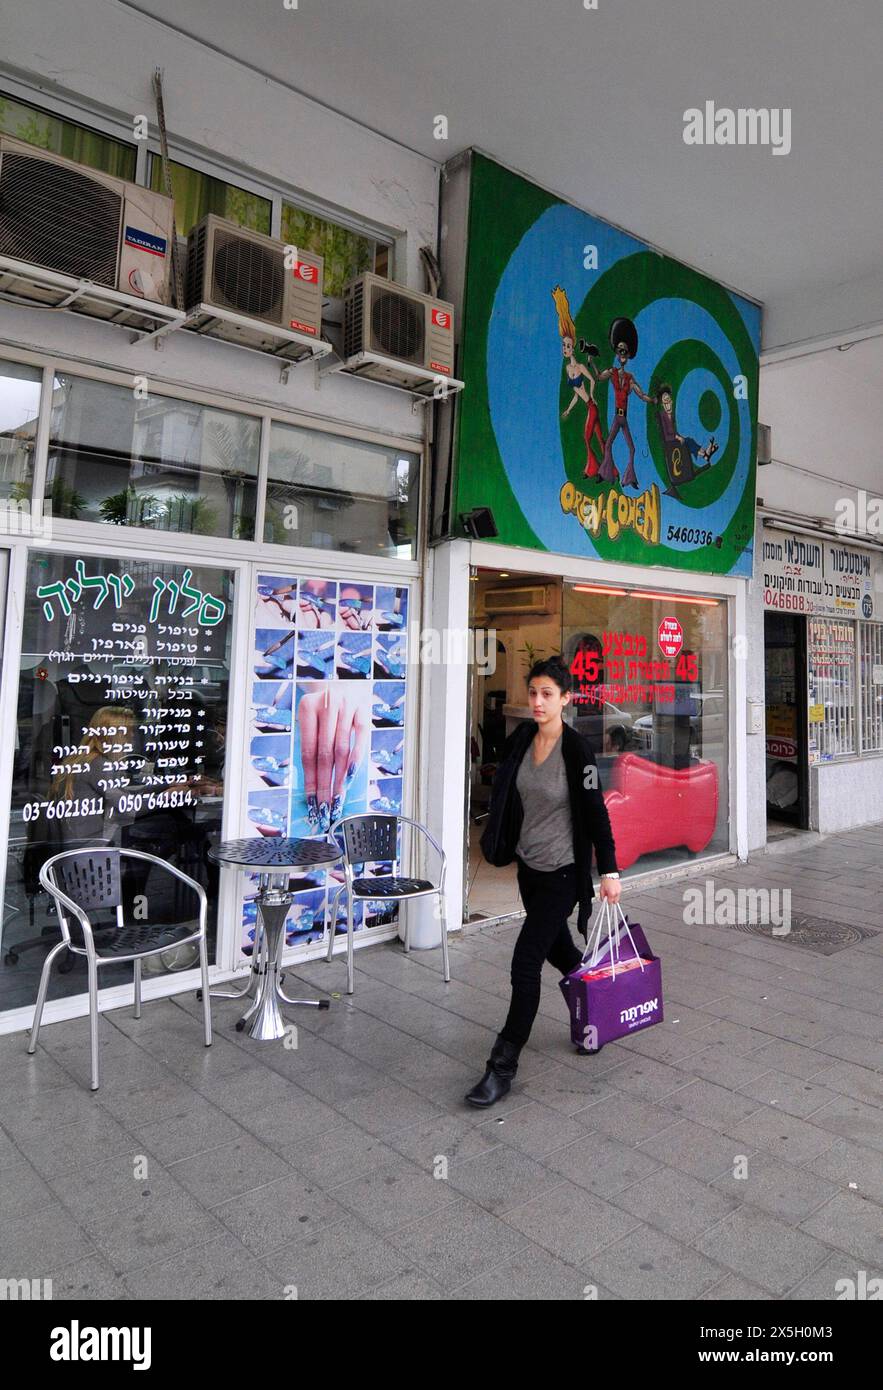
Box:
(28, 845), (211, 1091)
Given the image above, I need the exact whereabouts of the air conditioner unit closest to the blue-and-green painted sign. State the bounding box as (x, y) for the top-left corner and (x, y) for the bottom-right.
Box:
(343, 274), (453, 385)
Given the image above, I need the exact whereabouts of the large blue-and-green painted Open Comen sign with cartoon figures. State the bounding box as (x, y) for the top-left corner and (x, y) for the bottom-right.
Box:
(451, 153), (761, 574)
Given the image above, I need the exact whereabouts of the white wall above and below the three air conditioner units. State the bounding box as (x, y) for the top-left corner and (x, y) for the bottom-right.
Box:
(0, 0), (438, 436)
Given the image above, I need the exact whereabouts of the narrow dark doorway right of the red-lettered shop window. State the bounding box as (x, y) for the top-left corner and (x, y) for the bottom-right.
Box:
(763, 612), (809, 838)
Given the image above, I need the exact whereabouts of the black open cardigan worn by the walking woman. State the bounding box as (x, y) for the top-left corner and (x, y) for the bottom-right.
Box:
(481, 719), (617, 937)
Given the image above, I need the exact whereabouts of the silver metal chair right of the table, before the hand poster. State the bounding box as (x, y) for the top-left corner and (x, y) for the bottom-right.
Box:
(325, 815), (451, 994)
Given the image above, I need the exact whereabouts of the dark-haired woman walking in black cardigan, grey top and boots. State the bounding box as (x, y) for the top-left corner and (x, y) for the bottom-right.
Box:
(466, 656), (620, 1105)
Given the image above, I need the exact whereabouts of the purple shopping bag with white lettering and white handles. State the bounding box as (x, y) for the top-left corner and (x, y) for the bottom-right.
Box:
(560, 902), (662, 1052)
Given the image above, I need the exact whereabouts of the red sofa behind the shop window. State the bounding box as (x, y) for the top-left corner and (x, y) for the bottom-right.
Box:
(603, 753), (718, 869)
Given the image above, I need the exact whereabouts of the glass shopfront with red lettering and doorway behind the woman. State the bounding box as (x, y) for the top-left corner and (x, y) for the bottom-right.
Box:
(466, 558), (731, 919)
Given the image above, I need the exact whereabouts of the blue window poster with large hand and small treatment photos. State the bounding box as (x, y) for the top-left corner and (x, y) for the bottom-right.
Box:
(242, 571), (410, 954)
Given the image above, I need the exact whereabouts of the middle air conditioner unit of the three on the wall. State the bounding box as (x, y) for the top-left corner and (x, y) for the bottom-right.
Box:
(185, 213), (324, 352)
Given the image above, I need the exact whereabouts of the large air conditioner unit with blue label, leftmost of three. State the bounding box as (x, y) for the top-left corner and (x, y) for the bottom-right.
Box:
(0, 135), (175, 307)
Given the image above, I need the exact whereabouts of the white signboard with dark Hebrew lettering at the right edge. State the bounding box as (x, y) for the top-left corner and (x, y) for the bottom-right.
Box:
(761, 527), (883, 619)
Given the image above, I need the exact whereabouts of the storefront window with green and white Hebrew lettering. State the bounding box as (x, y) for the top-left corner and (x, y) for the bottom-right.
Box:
(0, 552), (234, 1011)
